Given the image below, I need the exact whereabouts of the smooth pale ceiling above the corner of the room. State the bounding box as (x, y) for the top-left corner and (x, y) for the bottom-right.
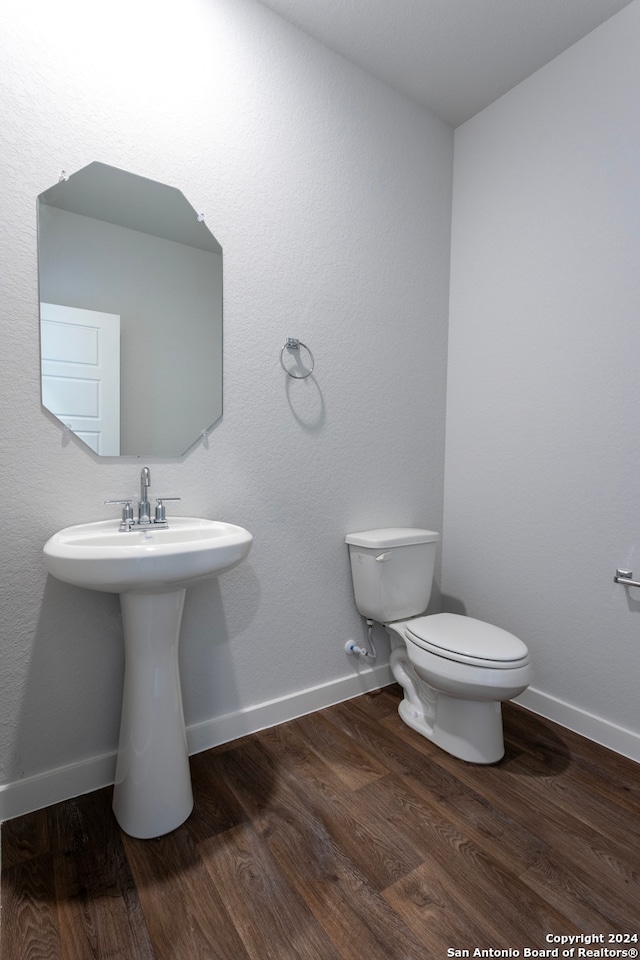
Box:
(261, 0), (631, 127)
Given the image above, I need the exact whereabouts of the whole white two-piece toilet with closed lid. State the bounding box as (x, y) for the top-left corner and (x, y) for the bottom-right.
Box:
(345, 527), (531, 763)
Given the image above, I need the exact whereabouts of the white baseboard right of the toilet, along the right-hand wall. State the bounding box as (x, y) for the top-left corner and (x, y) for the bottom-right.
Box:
(514, 687), (640, 763)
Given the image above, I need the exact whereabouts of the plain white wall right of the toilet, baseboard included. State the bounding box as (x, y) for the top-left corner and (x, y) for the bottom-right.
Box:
(442, 2), (640, 759)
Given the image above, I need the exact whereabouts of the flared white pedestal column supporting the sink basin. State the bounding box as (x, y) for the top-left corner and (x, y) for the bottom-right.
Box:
(113, 590), (193, 839)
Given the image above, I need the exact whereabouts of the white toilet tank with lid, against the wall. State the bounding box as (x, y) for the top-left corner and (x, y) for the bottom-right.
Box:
(345, 527), (440, 623)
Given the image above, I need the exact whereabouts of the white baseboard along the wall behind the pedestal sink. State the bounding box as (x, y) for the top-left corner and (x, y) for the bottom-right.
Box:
(0, 664), (393, 821)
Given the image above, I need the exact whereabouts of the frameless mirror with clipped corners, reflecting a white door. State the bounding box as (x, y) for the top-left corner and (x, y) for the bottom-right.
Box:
(38, 163), (222, 457)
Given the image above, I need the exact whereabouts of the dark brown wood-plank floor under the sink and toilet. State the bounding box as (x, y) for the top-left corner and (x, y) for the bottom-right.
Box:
(0, 686), (640, 960)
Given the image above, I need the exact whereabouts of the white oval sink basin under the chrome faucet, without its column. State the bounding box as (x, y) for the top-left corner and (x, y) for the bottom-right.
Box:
(44, 517), (253, 593)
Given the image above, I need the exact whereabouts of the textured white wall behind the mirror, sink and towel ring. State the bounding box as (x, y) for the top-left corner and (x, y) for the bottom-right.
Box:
(0, 0), (452, 817)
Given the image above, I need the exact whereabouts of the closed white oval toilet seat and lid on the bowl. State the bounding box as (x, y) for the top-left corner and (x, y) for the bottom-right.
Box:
(405, 613), (529, 670)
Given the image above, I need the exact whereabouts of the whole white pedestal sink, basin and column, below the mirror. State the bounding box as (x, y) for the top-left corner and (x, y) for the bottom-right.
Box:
(43, 517), (253, 839)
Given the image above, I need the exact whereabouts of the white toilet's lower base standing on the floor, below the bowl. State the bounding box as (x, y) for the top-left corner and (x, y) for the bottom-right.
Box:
(398, 691), (504, 764)
